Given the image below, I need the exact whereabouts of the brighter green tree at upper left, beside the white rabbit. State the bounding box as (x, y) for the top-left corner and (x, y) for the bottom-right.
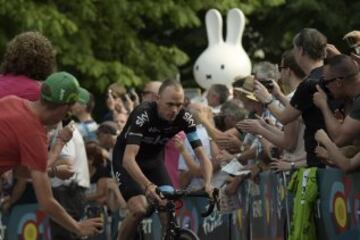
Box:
(0, 0), (281, 91)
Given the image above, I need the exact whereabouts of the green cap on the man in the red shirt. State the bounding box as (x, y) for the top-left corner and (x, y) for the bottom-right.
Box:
(41, 72), (89, 104)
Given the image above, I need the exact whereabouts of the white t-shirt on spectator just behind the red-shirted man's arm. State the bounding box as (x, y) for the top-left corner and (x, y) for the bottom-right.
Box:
(51, 128), (90, 188)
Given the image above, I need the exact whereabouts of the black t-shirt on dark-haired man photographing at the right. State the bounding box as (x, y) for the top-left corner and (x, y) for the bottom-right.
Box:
(290, 67), (326, 167)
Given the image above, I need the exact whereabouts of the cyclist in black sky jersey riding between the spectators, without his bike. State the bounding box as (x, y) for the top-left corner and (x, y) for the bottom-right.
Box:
(113, 80), (213, 239)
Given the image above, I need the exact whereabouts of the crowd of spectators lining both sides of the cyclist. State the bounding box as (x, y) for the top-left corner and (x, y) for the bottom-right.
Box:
(0, 28), (360, 239)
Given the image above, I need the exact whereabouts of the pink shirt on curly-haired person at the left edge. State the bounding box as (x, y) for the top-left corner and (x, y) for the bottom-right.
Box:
(0, 74), (41, 101)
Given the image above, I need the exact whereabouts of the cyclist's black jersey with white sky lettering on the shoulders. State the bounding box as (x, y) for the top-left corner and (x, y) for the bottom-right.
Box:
(113, 102), (201, 170)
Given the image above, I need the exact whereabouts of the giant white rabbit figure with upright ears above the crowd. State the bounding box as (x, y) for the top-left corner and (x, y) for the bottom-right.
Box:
(193, 8), (251, 89)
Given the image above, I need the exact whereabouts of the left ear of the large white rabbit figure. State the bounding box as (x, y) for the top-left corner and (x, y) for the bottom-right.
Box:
(205, 9), (224, 46)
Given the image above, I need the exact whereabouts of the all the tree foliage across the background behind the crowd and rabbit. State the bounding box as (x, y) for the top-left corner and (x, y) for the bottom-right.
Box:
(0, 0), (360, 91)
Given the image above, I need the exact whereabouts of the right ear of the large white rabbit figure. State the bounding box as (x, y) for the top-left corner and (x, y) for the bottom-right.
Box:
(226, 8), (245, 45)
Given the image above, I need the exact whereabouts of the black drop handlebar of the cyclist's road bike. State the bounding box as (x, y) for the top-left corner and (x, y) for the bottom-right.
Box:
(156, 187), (219, 218)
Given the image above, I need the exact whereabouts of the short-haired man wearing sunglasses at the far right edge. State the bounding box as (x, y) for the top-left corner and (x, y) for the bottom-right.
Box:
(314, 55), (360, 171)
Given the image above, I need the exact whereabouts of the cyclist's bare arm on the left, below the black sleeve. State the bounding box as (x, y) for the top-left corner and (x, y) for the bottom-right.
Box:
(123, 144), (152, 190)
